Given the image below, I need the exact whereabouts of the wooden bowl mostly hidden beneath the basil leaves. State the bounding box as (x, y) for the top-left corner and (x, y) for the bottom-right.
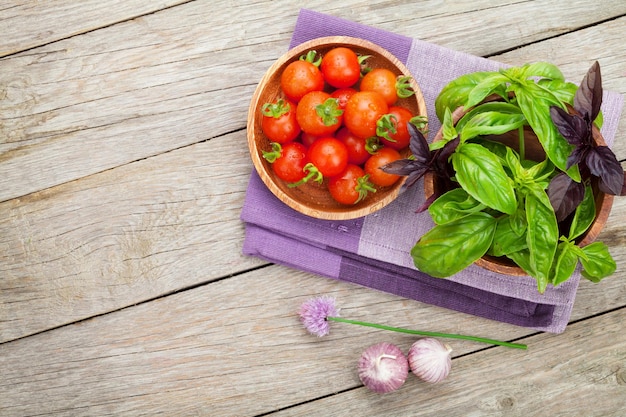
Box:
(424, 103), (613, 276)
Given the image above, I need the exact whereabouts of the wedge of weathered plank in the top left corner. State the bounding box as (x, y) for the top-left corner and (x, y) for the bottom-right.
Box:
(0, 0), (189, 57)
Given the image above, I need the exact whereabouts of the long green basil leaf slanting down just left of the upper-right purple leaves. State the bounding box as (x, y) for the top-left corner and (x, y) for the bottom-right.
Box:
(512, 83), (580, 181)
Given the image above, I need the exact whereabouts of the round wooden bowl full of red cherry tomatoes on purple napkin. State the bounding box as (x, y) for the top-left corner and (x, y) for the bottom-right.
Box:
(247, 36), (426, 220)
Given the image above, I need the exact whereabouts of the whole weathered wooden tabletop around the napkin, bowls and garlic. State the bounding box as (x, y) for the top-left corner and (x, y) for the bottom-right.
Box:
(0, 0), (626, 417)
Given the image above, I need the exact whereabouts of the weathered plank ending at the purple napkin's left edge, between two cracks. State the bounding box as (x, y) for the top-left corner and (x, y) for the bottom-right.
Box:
(0, 131), (262, 341)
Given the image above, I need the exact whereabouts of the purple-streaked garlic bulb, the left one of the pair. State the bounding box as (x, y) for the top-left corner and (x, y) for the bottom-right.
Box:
(358, 342), (409, 394)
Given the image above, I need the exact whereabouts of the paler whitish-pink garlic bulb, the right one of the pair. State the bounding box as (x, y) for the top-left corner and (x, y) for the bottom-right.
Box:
(408, 337), (452, 384)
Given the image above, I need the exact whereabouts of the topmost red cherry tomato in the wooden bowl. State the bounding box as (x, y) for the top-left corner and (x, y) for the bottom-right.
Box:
(320, 47), (361, 88)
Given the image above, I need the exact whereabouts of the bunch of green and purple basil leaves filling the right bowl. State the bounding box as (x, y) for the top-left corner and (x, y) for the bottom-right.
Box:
(384, 62), (626, 293)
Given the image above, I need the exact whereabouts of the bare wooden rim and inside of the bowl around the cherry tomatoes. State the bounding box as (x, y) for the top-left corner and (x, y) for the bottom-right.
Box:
(247, 36), (426, 220)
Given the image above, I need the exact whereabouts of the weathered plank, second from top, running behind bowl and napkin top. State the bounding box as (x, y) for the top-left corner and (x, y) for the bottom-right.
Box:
(0, 0), (626, 201)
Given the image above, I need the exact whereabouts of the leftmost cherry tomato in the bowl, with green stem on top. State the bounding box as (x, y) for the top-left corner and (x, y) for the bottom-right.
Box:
(261, 99), (300, 143)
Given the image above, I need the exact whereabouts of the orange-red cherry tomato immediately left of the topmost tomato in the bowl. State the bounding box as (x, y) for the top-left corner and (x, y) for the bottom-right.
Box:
(280, 60), (324, 103)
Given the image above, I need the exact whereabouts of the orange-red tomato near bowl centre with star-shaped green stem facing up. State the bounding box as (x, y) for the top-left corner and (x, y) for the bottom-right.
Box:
(296, 91), (343, 136)
